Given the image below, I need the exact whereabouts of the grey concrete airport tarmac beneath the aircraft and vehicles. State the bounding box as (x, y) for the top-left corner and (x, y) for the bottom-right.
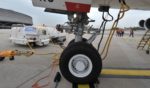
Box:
(0, 30), (150, 88)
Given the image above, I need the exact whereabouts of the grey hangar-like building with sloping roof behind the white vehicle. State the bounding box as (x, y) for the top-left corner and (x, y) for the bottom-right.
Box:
(0, 8), (33, 29)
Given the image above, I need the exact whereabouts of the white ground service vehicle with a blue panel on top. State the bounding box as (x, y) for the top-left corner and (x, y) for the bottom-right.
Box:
(9, 24), (50, 46)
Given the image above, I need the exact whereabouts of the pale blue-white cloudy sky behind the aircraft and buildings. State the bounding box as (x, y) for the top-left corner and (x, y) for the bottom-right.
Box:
(0, 0), (150, 28)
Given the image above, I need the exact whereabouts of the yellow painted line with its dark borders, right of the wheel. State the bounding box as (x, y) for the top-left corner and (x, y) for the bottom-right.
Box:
(101, 68), (150, 79)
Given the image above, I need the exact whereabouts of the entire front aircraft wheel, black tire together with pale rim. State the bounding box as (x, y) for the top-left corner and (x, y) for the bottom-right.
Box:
(59, 42), (102, 84)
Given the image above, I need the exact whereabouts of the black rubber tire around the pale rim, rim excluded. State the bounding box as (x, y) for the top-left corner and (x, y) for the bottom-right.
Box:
(59, 42), (102, 84)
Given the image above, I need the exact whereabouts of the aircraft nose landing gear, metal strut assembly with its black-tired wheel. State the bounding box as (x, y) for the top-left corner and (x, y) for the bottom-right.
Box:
(56, 13), (102, 84)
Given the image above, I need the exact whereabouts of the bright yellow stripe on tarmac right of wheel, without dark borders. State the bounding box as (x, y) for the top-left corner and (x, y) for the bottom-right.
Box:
(101, 69), (150, 76)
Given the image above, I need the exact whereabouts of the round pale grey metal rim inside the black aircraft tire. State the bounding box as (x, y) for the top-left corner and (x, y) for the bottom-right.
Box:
(69, 54), (93, 78)
